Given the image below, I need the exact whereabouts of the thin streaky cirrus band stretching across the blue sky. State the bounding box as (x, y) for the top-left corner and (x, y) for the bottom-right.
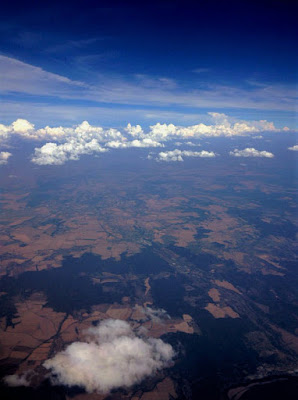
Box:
(0, 55), (296, 112)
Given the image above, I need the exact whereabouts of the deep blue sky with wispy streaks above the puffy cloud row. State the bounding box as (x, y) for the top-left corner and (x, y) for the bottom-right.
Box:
(0, 0), (297, 128)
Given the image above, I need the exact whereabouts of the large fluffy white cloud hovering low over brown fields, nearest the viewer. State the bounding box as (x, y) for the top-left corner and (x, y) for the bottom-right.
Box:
(43, 319), (174, 393)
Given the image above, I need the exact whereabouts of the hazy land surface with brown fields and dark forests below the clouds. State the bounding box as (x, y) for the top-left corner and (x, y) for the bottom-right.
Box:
(0, 134), (298, 400)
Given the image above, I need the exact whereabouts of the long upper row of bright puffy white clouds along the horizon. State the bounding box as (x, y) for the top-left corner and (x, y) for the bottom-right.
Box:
(0, 112), (280, 143)
